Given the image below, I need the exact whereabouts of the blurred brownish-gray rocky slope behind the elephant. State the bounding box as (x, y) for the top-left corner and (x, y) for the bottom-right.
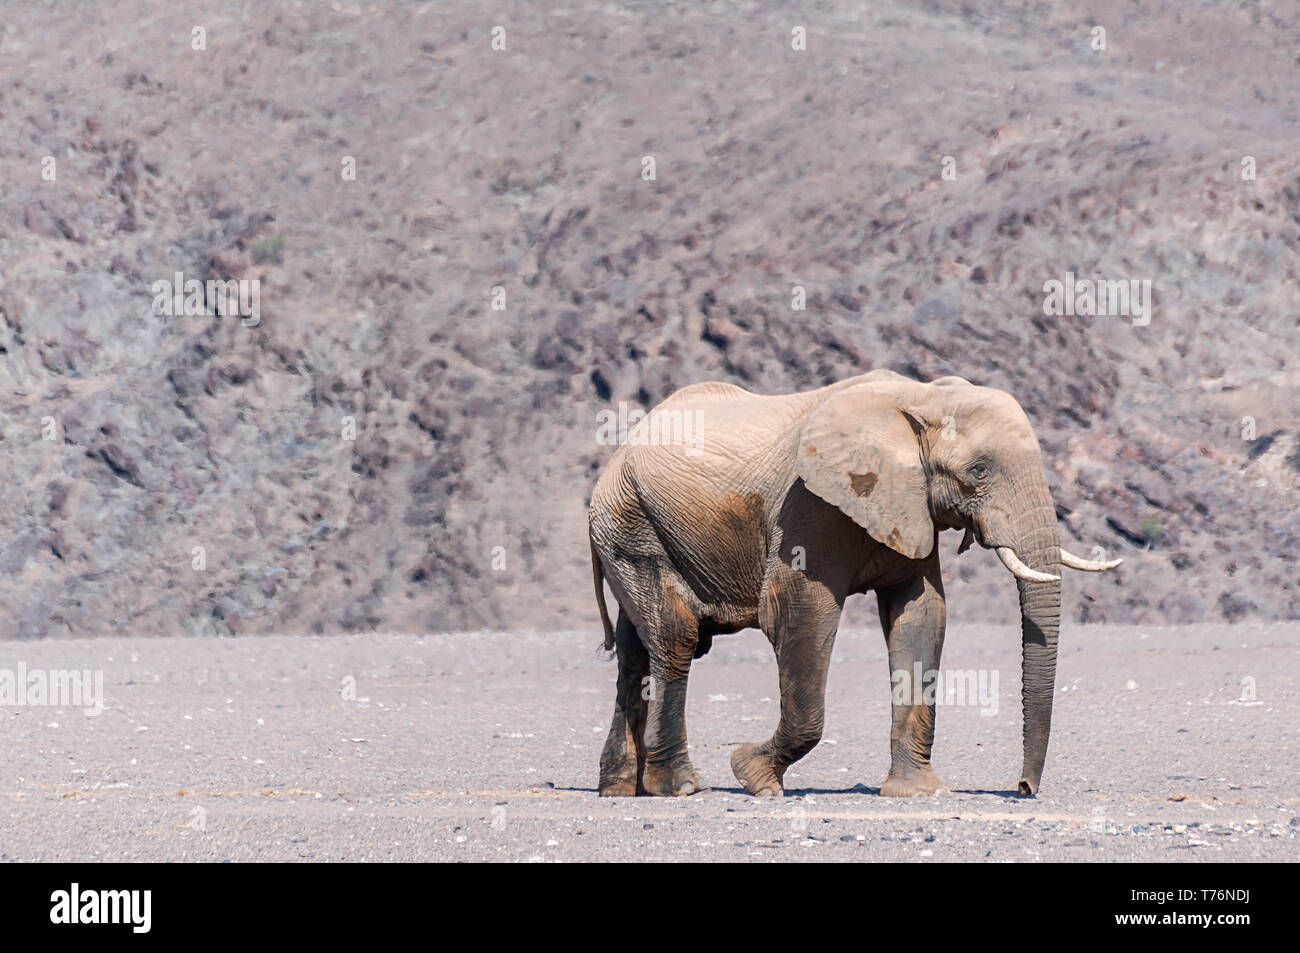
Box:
(0, 0), (1300, 640)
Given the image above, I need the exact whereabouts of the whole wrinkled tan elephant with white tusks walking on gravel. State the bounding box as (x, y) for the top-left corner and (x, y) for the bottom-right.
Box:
(588, 371), (1122, 797)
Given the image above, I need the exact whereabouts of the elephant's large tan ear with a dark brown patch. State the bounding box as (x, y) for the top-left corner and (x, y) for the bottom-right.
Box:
(797, 385), (935, 559)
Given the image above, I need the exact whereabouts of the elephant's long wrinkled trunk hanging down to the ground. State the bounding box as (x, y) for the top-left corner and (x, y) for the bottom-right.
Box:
(1014, 486), (1061, 796)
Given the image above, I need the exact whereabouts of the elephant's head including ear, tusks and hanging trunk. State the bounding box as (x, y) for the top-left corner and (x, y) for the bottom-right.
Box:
(797, 377), (1122, 794)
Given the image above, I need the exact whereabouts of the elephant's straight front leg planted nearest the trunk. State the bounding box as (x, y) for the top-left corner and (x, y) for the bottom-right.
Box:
(878, 558), (948, 797)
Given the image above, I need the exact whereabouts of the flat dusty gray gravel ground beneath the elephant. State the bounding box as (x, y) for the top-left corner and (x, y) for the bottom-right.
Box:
(0, 624), (1300, 862)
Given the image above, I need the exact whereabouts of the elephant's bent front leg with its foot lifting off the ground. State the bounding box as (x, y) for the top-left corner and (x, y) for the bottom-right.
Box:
(731, 572), (841, 797)
